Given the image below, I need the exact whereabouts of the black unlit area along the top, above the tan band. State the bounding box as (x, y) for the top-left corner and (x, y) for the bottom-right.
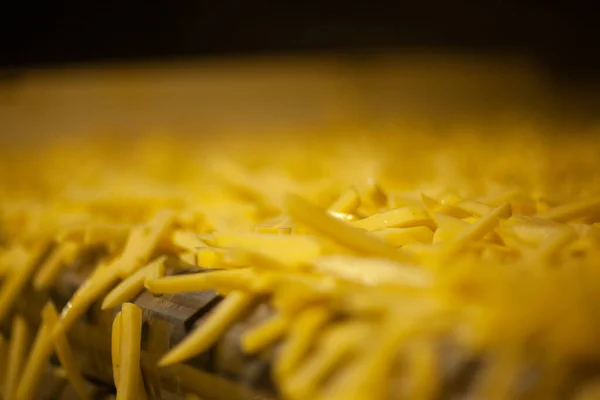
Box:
(0, 0), (600, 81)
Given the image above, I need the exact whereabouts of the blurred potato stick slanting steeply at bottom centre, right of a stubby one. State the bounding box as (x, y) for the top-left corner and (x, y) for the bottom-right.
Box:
(274, 306), (331, 381)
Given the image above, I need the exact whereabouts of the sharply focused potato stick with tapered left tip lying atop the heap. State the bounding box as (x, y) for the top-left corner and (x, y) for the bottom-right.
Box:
(351, 207), (431, 231)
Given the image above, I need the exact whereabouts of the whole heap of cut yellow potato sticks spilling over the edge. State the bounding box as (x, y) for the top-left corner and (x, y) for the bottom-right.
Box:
(0, 129), (600, 400)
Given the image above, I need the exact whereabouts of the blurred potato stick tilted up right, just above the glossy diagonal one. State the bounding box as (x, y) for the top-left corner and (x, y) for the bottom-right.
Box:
(119, 209), (175, 277)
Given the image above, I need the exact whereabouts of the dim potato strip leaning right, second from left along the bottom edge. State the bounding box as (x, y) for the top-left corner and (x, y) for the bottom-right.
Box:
(16, 322), (54, 400)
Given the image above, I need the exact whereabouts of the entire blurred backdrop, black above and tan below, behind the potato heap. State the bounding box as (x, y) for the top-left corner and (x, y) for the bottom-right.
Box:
(0, 0), (600, 143)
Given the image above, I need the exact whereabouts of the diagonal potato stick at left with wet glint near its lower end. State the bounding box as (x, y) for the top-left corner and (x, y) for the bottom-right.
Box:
(52, 266), (119, 336)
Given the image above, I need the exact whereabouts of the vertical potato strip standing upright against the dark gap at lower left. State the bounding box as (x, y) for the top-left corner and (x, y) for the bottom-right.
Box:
(117, 303), (146, 400)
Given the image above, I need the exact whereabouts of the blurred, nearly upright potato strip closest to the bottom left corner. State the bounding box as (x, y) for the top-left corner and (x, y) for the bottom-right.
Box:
(4, 315), (29, 399)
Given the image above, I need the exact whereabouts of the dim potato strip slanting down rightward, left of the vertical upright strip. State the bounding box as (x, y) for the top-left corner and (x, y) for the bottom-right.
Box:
(42, 302), (90, 400)
